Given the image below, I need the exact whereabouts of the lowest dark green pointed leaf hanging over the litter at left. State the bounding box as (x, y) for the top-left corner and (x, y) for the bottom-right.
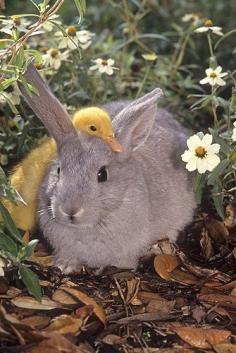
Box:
(19, 265), (42, 302)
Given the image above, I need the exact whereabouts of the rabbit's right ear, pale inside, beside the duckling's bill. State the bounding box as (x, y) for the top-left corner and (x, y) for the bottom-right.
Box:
(113, 88), (163, 152)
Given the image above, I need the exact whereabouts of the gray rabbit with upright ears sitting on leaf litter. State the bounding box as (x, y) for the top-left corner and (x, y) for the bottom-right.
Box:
(21, 65), (196, 273)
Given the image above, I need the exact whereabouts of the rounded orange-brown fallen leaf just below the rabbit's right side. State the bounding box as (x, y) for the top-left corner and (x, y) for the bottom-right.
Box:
(154, 254), (180, 281)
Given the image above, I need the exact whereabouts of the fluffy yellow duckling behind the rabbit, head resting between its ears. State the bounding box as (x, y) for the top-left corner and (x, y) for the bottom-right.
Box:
(4, 107), (122, 230)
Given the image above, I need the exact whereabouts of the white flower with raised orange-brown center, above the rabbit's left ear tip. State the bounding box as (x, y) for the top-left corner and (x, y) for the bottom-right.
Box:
(55, 26), (94, 50)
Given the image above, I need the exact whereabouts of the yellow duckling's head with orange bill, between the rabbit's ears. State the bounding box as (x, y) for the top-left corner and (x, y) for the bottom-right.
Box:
(73, 107), (123, 152)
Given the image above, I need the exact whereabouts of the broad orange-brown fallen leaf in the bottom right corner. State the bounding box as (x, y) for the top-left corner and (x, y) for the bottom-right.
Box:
(175, 327), (231, 349)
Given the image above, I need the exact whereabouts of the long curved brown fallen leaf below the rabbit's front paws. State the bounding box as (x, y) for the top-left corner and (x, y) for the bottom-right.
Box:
(53, 286), (107, 325)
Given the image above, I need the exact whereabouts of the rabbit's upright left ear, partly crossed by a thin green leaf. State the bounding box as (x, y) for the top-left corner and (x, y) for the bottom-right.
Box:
(19, 64), (76, 145)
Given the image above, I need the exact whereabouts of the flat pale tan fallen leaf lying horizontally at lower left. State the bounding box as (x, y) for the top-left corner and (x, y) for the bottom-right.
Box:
(11, 296), (61, 310)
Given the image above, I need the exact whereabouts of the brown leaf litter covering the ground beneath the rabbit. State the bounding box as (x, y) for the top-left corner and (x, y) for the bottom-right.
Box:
(0, 210), (236, 353)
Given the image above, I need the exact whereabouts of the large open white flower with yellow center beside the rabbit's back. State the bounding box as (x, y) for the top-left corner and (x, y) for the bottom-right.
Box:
(181, 134), (220, 174)
